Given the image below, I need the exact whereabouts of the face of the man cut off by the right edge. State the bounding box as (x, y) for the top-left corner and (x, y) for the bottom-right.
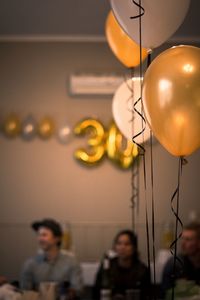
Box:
(181, 230), (200, 256)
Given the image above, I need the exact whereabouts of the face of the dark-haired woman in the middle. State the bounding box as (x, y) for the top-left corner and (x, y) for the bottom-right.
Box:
(115, 234), (135, 259)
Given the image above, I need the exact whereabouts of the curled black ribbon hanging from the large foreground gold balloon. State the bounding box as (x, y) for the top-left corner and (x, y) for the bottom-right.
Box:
(170, 156), (187, 300)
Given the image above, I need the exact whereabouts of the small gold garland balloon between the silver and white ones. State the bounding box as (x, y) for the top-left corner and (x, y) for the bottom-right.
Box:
(38, 117), (55, 140)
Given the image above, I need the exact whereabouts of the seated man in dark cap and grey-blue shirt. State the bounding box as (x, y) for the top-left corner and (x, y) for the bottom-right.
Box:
(21, 219), (82, 298)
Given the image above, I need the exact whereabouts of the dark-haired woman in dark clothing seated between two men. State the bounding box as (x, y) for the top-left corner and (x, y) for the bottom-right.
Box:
(93, 230), (150, 300)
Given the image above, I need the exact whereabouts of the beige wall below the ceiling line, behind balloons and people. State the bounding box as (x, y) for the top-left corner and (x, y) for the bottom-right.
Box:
(0, 42), (200, 278)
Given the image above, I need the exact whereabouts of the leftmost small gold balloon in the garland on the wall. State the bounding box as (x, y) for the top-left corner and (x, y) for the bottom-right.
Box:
(3, 114), (21, 138)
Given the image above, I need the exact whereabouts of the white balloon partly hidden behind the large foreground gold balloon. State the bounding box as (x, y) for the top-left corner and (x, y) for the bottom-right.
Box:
(112, 78), (150, 144)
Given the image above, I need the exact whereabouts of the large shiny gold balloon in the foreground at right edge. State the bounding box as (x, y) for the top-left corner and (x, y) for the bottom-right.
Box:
(143, 46), (200, 156)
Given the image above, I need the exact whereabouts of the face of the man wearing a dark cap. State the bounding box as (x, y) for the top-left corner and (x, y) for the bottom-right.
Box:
(37, 227), (59, 251)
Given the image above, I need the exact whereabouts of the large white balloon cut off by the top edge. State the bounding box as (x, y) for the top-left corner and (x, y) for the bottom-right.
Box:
(110, 0), (190, 49)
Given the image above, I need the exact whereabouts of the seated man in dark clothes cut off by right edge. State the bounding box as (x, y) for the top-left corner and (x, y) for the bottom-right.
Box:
(162, 222), (200, 297)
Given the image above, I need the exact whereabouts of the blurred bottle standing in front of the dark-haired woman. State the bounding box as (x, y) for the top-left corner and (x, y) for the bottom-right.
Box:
(100, 255), (112, 300)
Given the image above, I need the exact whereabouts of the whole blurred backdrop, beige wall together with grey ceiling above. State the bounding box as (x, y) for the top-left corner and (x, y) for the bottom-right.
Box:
(0, 0), (200, 279)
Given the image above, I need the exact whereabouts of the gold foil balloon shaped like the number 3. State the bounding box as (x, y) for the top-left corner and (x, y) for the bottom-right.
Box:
(74, 119), (105, 166)
